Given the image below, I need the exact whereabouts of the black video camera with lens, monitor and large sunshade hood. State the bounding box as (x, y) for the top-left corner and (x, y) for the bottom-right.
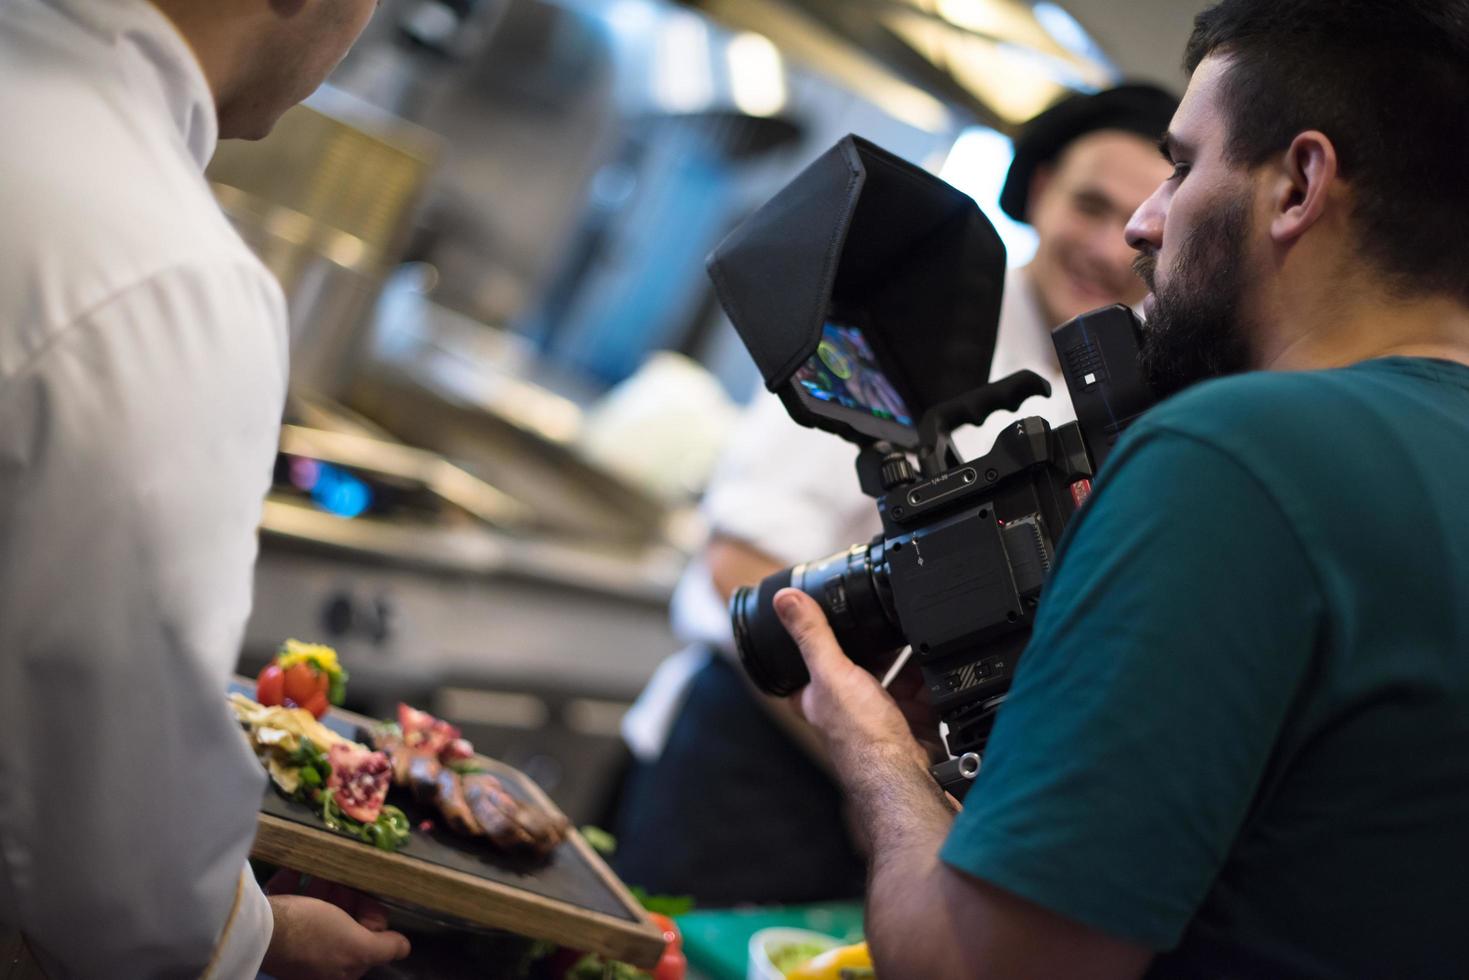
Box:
(708, 137), (1153, 793)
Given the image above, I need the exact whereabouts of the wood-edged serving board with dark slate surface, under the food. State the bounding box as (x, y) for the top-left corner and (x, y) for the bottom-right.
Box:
(231, 679), (663, 967)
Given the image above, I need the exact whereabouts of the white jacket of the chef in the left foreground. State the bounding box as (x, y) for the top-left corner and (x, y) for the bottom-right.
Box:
(0, 0), (286, 980)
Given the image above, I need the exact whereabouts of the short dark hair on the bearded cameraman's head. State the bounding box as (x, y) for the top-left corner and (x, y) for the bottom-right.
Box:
(1184, 0), (1469, 301)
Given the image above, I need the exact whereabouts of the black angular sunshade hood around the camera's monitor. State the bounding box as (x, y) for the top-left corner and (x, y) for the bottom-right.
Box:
(707, 135), (1005, 438)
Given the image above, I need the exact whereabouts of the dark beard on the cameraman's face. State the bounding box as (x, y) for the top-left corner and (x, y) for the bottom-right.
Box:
(1133, 195), (1250, 398)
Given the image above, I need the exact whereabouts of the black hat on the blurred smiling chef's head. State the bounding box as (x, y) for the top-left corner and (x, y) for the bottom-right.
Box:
(1000, 84), (1178, 222)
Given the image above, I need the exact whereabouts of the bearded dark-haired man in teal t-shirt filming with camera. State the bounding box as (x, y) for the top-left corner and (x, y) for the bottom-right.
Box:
(776, 0), (1469, 980)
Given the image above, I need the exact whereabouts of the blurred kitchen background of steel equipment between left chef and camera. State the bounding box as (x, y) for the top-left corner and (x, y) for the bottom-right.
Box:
(210, 0), (1203, 821)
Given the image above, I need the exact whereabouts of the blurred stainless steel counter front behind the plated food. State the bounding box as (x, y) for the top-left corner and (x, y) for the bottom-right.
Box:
(245, 531), (676, 699)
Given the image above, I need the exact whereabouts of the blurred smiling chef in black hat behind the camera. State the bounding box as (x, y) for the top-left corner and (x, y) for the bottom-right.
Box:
(616, 85), (1178, 905)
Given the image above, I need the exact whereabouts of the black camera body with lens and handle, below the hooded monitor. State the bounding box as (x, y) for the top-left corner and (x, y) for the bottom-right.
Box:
(730, 307), (1152, 775)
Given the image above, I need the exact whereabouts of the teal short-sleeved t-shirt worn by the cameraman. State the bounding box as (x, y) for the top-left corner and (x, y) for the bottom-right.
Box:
(943, 357), (1469, 979)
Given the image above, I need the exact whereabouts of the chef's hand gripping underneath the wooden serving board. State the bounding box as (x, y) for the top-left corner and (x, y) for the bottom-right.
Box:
(260, 871), (410, 980)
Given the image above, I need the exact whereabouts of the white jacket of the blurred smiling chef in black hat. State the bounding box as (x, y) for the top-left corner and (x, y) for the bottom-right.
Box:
(623, 262), (1077, 761)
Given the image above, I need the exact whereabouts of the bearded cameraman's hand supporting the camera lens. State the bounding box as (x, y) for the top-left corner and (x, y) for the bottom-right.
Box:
(774, 589), (937, 770)
